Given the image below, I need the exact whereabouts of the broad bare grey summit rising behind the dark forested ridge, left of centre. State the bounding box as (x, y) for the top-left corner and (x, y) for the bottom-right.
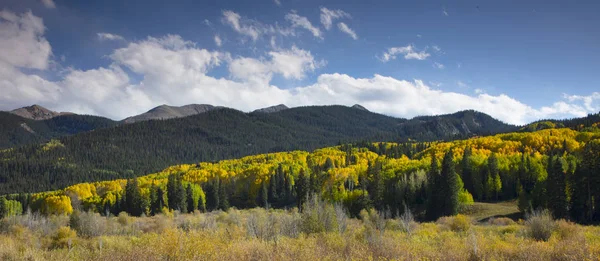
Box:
(123, 104), (219, 123)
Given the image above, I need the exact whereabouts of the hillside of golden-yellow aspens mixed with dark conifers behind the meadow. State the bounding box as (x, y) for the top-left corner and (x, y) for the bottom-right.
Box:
(9, 128), (600, 222)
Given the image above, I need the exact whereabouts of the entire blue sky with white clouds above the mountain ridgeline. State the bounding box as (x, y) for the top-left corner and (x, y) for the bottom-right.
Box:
(0, 0), (600, 124)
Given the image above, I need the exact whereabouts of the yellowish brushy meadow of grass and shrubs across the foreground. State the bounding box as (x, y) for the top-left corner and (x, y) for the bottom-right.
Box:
(0, 204), (600, 261)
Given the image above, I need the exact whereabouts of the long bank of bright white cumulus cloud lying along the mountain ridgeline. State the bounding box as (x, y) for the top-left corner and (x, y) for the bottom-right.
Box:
(0, 9), (600, 124)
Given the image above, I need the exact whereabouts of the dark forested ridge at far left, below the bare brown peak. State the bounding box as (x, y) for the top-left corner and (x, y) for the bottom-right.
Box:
(0, 111), (117, 149)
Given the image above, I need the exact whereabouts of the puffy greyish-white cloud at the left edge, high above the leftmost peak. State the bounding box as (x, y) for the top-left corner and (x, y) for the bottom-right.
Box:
(0, 10), (52, 70)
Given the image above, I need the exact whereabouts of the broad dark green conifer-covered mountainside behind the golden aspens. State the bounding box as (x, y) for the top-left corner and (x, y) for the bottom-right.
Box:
(0, 106), (515, 193)
